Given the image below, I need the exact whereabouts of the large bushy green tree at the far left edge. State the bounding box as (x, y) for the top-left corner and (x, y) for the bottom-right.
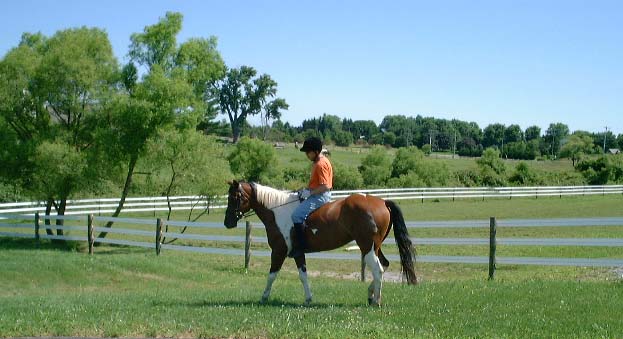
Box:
(0, 27), (118, 234)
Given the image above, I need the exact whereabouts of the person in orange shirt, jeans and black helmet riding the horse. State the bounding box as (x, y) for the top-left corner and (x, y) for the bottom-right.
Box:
(289, 137), (333, 258)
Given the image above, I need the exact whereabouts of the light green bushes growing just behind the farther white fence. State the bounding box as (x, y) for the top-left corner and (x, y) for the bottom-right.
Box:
(221, 137), (623, 190)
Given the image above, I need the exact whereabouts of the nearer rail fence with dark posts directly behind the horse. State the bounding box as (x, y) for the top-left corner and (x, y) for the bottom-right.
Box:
(0, 214), (623, 267)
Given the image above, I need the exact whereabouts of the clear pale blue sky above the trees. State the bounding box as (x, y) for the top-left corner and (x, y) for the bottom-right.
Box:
(0, 0), (623, 135)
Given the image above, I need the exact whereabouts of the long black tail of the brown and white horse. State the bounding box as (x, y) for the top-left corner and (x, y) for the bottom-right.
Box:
(385, 200), (417, 284)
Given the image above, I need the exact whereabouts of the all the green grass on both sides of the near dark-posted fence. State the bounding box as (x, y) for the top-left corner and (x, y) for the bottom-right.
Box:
(0, 196), (623, 338)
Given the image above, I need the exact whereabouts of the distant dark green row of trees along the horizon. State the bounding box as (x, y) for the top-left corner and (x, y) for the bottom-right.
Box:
(214, 114), (623, 163)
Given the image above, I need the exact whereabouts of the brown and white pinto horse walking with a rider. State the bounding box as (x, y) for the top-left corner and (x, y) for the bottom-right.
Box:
(224, 180), (418, 306)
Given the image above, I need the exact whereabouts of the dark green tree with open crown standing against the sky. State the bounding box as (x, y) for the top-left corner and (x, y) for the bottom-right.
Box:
(217, 66), (287, 143)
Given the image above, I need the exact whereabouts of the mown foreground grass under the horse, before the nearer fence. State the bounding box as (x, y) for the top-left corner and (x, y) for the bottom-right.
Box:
(0, 243), (623, 338)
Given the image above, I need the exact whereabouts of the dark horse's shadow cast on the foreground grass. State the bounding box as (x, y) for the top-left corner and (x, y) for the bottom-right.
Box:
(153, 299), (366, 309)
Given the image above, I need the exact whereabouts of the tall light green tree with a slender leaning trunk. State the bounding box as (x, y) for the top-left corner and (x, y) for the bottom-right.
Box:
(99, 12), (225, 237)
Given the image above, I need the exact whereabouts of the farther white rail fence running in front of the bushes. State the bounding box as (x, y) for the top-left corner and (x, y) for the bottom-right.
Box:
(0, 185), (623, 215)
